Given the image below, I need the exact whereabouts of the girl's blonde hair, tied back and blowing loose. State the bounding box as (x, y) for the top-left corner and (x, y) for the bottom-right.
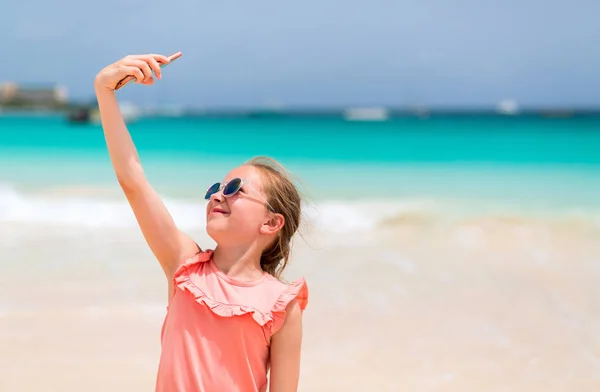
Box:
(245, 157), (302, 279)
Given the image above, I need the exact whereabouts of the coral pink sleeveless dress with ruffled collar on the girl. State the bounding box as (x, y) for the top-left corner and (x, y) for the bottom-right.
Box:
(156, 250), (308, 392)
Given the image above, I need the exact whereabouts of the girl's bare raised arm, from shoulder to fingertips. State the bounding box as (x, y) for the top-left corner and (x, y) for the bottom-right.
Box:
(94, 55), (199, 284)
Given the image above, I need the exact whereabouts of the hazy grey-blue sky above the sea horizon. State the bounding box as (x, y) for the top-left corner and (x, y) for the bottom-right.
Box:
(0, 0), (600, 108)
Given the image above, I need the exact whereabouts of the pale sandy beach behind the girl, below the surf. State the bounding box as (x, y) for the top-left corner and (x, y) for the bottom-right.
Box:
(0, 213), (600, 392)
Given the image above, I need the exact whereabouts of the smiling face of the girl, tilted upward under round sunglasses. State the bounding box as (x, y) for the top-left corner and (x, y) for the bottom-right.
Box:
(206, 166), (273, 245)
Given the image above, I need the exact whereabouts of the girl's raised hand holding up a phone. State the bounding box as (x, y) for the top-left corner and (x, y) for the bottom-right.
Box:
(94, 54), (169, 91)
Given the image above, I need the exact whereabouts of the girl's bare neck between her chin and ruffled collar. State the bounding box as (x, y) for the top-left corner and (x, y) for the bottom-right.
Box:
(213, 245), (263, 281)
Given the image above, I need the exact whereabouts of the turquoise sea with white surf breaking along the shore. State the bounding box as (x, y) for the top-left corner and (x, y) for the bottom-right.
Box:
(0, 115), (600, 233)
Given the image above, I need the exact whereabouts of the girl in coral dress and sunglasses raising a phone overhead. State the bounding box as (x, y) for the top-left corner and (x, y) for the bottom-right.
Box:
(95, 54), (308, 392)
